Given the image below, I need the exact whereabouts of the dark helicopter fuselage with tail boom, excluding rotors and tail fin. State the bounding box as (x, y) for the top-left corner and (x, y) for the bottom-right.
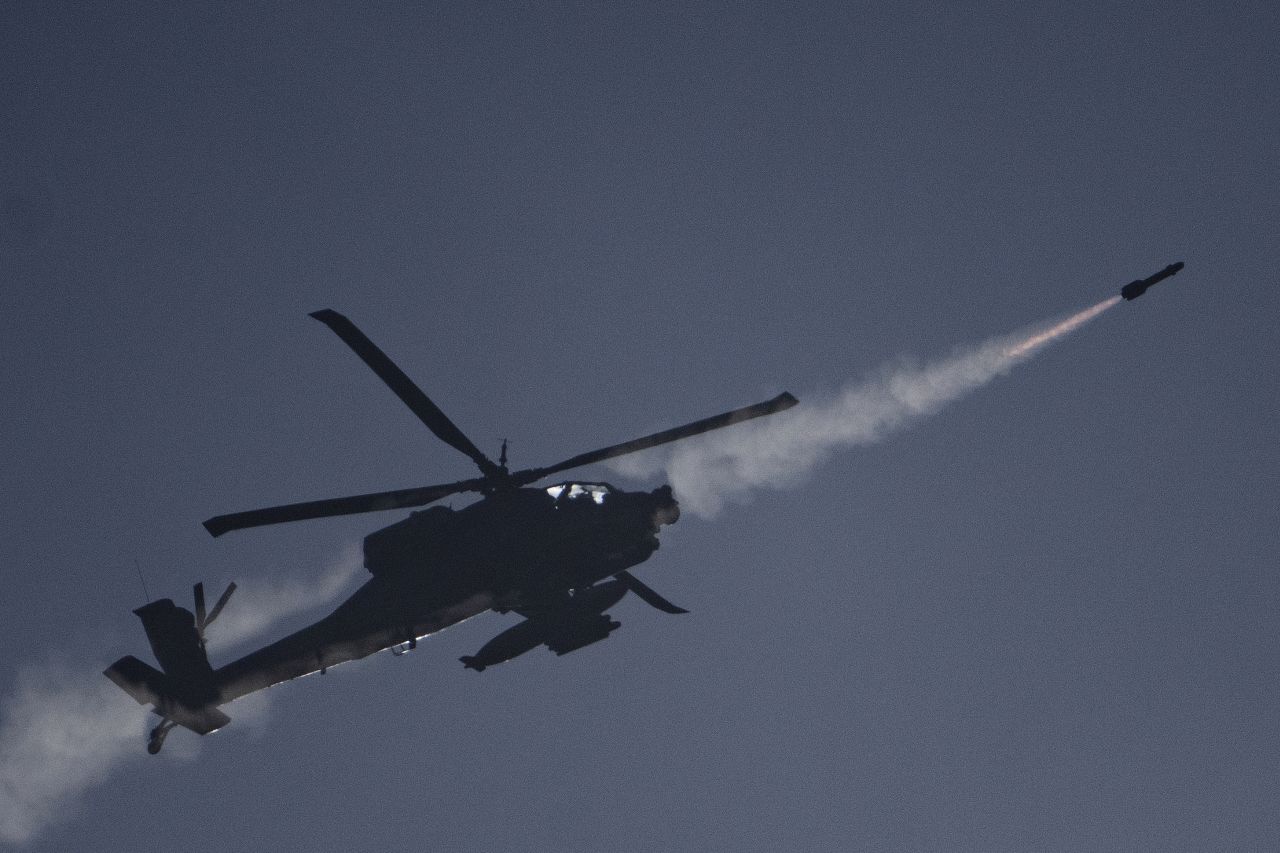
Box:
(214, 483), (680, 704)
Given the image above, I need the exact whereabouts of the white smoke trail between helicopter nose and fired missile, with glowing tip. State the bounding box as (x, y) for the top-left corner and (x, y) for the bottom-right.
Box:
(617, 296), (1120, 516)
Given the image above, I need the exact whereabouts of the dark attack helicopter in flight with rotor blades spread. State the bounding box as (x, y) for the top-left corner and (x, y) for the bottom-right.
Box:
(104, 309), (797, 754)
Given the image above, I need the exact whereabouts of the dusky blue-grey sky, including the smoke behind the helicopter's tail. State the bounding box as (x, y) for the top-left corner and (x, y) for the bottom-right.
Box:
(0, 1), (1280, 850)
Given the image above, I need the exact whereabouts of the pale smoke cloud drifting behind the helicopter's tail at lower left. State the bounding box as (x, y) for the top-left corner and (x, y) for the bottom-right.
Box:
(0, 546), (361, 844)
